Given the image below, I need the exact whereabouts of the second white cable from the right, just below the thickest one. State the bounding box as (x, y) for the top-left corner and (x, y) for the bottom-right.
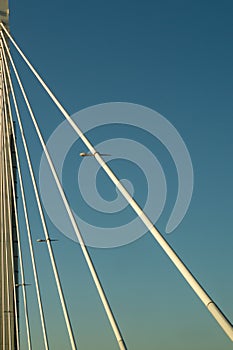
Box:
(2, 26), (126, 350)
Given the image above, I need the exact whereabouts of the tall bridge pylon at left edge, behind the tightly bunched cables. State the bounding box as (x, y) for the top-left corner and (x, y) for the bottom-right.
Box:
(0, 0), (19, 350)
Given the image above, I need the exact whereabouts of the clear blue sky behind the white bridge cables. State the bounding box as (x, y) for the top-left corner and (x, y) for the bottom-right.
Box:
(7, 0), (233, 350)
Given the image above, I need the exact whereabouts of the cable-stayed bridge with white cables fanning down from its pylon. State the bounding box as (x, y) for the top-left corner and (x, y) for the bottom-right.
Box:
(0, 1), (233, 350)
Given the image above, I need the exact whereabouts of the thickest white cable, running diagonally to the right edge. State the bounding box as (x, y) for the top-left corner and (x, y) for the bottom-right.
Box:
(1, 23), (233, 341)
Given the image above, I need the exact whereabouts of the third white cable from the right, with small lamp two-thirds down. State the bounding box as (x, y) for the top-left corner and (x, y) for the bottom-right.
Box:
(3, 39), (77, 350)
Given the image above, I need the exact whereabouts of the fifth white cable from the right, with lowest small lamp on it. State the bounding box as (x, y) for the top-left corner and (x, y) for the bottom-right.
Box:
(3, 55), (31, 350)
